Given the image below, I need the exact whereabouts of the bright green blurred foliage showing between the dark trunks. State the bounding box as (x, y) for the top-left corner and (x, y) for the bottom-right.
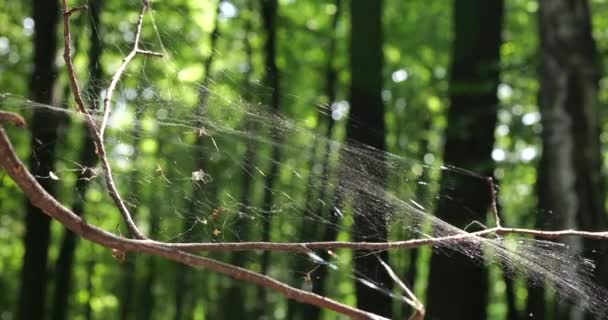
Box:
(0, 0), (608, 319)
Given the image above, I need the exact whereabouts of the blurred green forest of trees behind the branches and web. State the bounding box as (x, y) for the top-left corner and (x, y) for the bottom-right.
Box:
(0, 0), (608, 320)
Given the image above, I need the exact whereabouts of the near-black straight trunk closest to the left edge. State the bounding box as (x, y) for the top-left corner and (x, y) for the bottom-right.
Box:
(17, 0), (59, 320)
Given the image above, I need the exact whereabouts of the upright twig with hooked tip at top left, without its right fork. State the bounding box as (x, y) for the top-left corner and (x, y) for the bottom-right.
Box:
(62, 0), (146, 239)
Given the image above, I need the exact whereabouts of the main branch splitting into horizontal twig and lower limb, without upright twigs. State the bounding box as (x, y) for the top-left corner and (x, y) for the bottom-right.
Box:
(5, 117), (608, 319)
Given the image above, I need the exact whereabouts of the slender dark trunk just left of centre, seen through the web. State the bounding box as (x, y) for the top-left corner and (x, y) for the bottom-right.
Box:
(257, 0), (281, 318)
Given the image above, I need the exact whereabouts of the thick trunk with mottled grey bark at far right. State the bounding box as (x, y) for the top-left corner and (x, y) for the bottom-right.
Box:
(528, 0), (608, 319)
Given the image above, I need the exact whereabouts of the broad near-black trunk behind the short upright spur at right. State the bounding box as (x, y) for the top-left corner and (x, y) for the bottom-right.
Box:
(427, 0), (503, 320)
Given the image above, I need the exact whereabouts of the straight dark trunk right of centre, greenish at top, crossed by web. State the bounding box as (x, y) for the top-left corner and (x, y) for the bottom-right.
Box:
(344, 0), (392, 318)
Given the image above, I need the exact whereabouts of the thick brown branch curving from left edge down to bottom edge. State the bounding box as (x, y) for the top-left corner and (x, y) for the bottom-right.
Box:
(0, 126), (384, 319)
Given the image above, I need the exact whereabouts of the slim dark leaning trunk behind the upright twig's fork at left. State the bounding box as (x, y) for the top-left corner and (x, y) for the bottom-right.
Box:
(52, 0), (103, 320)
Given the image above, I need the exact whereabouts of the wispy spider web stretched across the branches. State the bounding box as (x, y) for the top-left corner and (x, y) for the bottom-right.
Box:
(0, 1), (608, 318)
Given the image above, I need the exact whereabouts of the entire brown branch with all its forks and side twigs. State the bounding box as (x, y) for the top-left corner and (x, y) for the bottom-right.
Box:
(8, 0), (608, 320)
